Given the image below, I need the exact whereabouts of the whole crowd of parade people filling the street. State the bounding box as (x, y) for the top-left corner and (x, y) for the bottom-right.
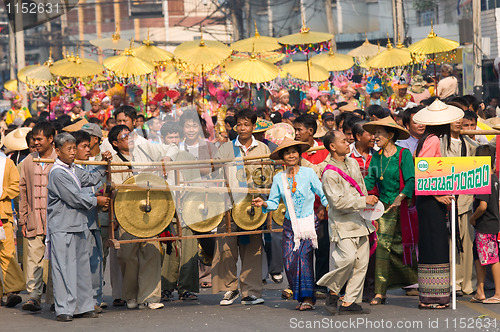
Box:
(0, 65), (500, 321)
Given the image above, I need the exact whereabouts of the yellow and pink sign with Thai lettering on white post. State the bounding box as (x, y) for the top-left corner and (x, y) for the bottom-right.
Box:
(415, 157), (491, 310)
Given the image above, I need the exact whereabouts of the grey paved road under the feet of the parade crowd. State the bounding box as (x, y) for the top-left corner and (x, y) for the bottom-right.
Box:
(0, 272), (500, 332)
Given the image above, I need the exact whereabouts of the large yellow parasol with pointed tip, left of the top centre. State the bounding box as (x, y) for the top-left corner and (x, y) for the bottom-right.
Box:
(174, 35), (232, 70)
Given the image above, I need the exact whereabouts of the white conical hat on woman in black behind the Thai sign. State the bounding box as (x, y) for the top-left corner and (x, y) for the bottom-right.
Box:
(413, 99), (464, 126)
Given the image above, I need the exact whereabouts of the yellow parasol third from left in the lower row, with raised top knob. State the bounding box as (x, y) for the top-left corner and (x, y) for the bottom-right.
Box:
(104, 48), (155, 77)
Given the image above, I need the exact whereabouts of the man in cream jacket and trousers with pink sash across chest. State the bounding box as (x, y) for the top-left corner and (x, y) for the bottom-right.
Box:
(318, 130), (378, 314)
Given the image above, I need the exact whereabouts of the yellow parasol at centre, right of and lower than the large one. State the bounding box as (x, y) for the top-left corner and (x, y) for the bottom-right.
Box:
(226, 54), (279, 83)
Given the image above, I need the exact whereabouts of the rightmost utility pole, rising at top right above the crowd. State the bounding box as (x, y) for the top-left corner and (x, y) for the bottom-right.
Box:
(472, 0), (483, 100)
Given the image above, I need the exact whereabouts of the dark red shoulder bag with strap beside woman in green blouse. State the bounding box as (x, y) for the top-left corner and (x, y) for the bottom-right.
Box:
(399, 149), (418, 265)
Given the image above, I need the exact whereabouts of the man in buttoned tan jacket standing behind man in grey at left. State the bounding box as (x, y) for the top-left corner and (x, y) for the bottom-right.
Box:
(19, 122), (57, 311)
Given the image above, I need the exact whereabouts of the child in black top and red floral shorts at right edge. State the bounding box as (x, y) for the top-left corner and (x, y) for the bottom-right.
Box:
(470, 145), (500, 304)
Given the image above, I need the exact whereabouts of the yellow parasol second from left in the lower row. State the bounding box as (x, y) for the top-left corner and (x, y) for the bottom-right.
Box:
(50, 55), (104, 78)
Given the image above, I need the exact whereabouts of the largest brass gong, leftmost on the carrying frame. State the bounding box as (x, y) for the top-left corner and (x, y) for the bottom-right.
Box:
(113, 173), (175, 238)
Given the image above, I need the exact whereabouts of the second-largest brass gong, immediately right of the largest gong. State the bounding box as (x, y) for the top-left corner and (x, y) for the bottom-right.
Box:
(182, 192), (226, 233)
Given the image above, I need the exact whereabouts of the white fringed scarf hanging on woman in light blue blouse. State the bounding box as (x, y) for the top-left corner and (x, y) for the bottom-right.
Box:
(281, 172), (318, 251)
